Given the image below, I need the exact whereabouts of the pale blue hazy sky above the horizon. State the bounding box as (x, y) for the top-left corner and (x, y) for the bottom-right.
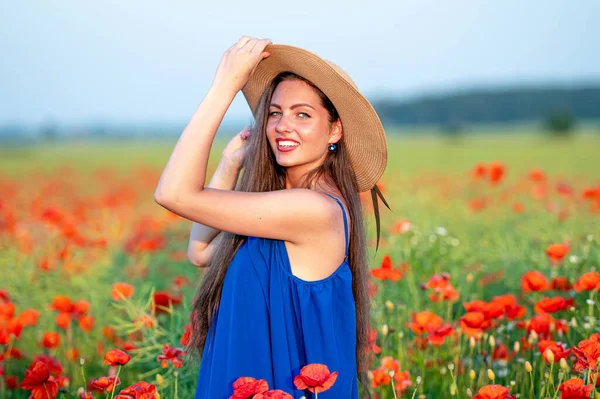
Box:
(0, 0), (600, 125)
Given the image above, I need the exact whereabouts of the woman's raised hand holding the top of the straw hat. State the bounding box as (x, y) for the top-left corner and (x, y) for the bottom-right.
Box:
(213, 36), (271, 94)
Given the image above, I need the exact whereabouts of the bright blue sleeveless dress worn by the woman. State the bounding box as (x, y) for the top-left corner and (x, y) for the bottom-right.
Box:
(194, 194), (358, 399)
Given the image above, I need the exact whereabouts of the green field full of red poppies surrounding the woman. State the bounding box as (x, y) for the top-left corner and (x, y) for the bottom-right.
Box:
(0, 132), (600, 399)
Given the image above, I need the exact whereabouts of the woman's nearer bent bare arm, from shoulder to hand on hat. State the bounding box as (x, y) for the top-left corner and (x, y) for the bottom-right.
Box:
(154, 36), (337, 243)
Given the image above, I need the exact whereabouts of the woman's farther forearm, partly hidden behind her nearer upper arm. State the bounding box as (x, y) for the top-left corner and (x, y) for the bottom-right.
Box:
(188, 161), (239, 250)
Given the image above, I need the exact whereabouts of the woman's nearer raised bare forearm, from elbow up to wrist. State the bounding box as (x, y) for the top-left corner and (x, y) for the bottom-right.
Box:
(154, 86), (236, 202)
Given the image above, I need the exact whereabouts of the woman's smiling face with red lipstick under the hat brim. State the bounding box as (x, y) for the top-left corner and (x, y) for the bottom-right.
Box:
(267, 80), (342, 171)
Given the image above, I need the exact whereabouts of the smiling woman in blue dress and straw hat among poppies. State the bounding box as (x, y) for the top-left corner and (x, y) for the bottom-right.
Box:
(154, 36), (387, 399)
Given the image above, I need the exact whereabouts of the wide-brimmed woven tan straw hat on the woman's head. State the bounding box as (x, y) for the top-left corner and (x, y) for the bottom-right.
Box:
(242, 44), (387, 192)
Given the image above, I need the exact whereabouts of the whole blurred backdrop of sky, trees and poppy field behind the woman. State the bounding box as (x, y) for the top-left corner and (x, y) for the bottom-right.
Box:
(0, 0), (600, 399)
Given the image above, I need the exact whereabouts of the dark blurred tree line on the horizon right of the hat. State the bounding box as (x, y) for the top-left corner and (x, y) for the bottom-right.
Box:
(373, 85), (600, 131)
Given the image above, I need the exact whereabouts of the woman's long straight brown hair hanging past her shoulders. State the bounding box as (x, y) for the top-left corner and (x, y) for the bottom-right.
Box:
(187, 72), (370, 391)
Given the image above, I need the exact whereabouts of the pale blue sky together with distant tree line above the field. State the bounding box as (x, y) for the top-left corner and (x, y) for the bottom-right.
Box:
(0, 0), (600, 146)
